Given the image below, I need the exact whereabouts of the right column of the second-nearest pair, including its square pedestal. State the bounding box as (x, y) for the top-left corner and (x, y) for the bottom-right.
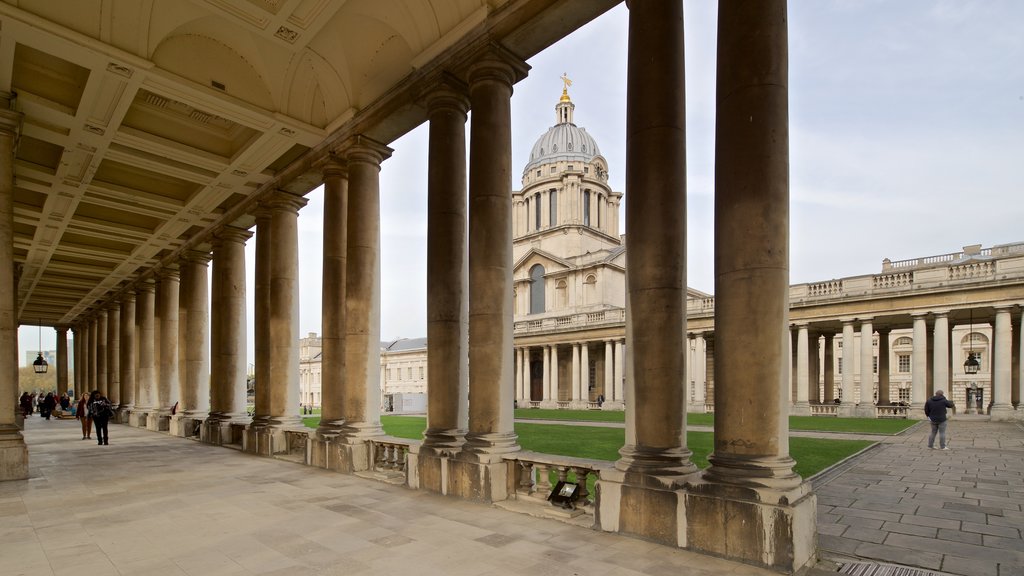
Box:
(453, 45), (528, 501)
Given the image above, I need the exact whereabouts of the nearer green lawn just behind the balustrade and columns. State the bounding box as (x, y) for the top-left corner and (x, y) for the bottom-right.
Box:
(303, 416), (871, 478)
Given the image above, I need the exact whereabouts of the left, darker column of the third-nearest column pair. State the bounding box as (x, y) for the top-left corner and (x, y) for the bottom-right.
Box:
(316, 158), (350, 439)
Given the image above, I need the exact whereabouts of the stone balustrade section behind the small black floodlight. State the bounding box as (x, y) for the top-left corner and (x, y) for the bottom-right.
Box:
(504, 451), (613, 517)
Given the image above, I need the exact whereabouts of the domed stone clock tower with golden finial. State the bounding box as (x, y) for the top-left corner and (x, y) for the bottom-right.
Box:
(512, 84), (626, 317)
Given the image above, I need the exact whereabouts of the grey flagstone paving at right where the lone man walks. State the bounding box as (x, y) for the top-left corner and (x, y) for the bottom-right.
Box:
(815, 416), (1024, 576)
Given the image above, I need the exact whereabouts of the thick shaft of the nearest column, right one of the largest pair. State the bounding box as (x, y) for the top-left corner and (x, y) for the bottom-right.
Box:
(708, 1), (794, 489)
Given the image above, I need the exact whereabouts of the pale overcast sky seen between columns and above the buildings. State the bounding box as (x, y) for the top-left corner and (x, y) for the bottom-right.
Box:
(20, 0), (1024, 362)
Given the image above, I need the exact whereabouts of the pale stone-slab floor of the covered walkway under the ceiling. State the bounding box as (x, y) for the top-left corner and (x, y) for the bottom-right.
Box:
(0, 415), (775, 576)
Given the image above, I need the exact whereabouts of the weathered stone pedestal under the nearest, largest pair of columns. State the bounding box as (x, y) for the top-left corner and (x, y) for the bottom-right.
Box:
(596, 470), (817, 573)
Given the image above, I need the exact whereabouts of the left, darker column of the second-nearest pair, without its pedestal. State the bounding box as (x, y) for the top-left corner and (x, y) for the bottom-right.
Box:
(421, 77), (468, 457)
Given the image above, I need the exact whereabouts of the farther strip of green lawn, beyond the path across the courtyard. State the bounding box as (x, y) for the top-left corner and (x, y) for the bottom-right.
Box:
(515, 408), (916, 435)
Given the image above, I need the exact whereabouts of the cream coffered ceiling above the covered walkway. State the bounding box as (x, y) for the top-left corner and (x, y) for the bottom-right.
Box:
(0, 0), (615, 325)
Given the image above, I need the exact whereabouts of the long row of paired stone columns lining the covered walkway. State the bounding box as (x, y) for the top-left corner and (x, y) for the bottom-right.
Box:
(0, 0), (815, 570)
